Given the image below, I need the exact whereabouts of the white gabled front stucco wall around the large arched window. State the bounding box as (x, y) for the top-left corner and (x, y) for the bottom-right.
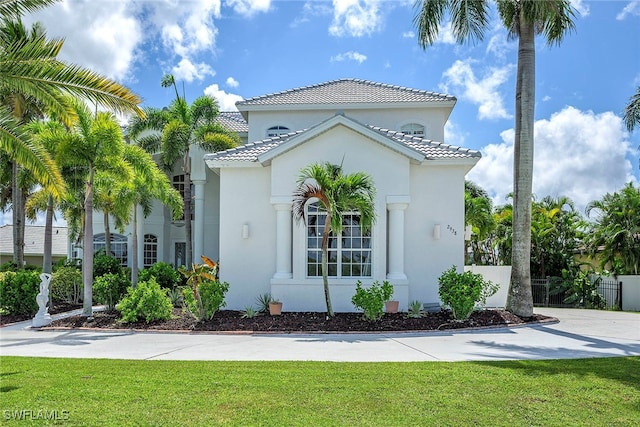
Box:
(220, 125), (466, 311)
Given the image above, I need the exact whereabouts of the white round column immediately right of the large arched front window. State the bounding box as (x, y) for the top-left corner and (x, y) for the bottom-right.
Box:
(387, 196), (409, 280)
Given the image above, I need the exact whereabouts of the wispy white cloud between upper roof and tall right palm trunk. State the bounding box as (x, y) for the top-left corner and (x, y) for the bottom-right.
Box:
(441, 59), (513, 119)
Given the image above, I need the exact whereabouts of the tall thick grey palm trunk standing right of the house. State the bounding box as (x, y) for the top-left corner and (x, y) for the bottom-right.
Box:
(506, 14), (535, 317)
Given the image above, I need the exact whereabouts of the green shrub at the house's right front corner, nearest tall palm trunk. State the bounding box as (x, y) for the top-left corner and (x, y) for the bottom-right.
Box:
(438, 265), (499, 320)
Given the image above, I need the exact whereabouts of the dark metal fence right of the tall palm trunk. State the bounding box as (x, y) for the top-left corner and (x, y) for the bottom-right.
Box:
(531, 277), (622, 310)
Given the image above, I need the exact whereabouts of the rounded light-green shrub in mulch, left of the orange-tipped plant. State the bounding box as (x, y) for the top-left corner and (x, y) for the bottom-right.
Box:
(116, 277), (173, 323)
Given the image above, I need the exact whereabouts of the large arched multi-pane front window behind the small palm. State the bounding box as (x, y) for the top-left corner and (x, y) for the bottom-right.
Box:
(306, 202), (372, 277)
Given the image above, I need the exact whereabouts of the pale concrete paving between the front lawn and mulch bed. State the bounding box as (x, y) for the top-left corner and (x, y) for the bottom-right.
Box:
(0, 308), (640, 362)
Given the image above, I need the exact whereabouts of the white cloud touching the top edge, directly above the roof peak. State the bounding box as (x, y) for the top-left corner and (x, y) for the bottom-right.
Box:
(329, 0), (382, 37)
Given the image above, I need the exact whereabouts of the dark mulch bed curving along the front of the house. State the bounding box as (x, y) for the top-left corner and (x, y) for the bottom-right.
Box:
(42, 309), (554, 333)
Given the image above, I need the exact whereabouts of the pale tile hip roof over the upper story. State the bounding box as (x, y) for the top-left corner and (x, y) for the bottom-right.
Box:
(236, 79), (456, 110)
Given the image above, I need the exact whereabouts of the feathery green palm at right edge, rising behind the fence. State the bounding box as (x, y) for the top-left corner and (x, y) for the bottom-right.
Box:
(586, 182), (640, 274)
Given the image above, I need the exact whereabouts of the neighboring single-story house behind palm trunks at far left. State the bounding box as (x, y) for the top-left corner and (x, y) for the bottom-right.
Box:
(0, 224), (68, 267)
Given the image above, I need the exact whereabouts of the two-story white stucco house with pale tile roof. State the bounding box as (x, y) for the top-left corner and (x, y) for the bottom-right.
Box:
(86, 79), (480, 311)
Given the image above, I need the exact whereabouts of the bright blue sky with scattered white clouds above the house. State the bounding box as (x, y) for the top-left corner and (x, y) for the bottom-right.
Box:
(5, 0), (640, 227)
